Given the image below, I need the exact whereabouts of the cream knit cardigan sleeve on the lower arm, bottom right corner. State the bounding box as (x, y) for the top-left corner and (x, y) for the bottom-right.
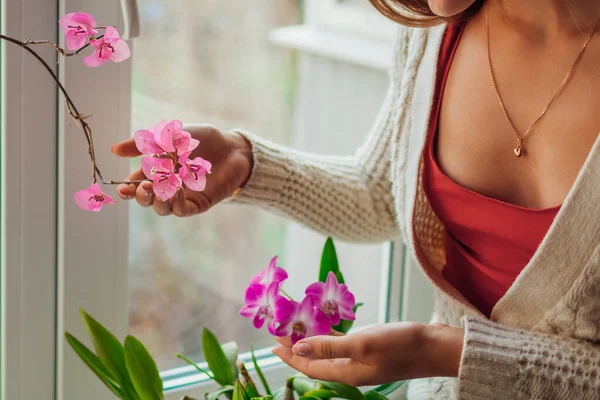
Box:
(458, 317), (600, 400)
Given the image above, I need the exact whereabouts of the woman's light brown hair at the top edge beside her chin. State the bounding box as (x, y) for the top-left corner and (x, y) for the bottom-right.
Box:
(369, 0), (483, 27)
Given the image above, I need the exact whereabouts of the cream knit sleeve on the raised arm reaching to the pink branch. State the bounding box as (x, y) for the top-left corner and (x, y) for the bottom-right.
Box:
(227, 29), (408, 242)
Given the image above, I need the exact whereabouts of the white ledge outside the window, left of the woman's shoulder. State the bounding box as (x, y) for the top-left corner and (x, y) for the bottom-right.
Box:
(270, 25), (393, 71)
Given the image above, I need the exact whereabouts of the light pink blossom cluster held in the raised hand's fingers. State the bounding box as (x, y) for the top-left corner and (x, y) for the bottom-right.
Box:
(135, 120), (212, 201)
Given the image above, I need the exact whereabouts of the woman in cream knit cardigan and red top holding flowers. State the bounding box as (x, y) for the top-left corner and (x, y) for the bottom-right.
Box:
(113, 0), (600, 399)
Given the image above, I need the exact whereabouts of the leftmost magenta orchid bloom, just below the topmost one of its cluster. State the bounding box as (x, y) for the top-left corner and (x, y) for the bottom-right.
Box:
(240, 282), (280, 334)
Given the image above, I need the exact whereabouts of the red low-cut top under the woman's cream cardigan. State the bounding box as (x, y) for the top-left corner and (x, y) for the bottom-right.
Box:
(423, 25), (560, 317)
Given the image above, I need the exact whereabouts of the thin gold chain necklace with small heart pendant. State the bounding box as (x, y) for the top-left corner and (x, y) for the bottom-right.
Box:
(485, 6), (600, 157)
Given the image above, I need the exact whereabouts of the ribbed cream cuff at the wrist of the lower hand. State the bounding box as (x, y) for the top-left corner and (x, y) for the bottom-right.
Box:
(457, 317), (526, 400)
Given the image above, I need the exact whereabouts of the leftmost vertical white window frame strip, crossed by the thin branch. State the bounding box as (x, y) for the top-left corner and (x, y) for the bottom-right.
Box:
(0, 0), (57, 400)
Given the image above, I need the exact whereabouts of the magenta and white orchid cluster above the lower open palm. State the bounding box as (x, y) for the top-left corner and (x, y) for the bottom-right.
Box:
(240, 257), (356, 343)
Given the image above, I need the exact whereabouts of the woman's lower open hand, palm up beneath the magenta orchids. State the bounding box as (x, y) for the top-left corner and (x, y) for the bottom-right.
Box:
(273, 322), (464, 386)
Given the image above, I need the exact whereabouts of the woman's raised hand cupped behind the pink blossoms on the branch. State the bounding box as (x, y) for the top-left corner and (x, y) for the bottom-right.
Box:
(111, 125), (253, 217)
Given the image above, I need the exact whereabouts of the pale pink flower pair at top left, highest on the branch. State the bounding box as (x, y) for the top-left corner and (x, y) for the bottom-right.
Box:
(58, 13), (131, 67)
